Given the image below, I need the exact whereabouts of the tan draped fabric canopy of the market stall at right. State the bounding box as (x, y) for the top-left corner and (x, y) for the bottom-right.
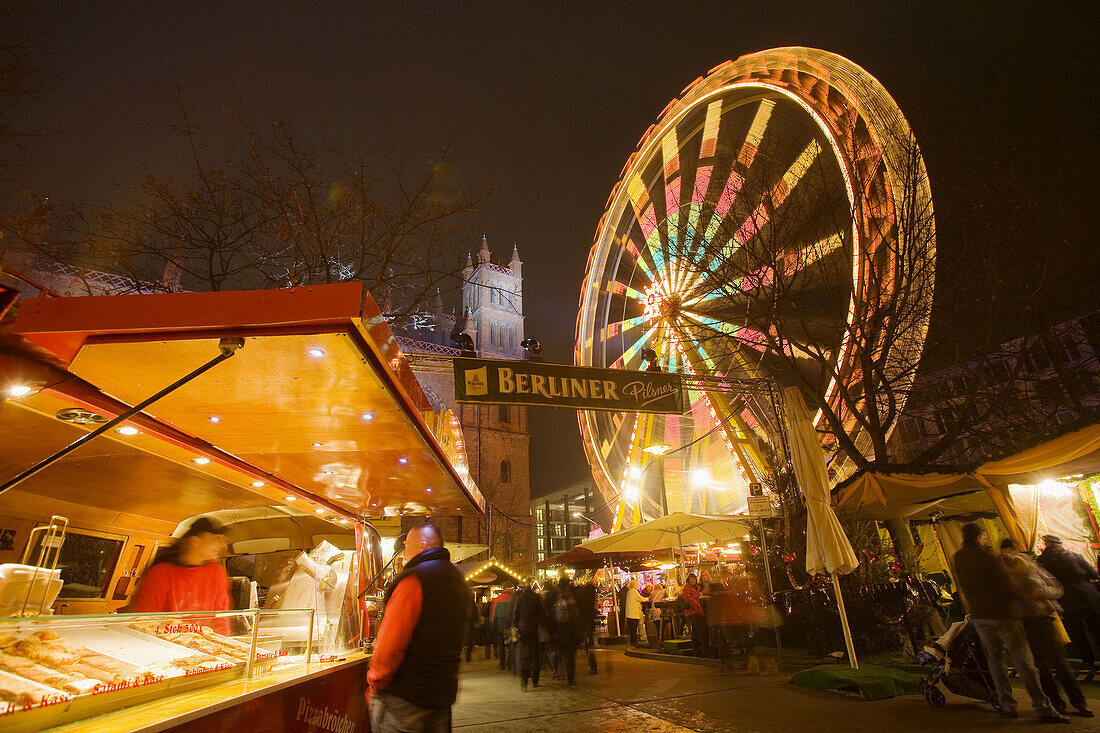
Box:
(833, 416), (1100, 547)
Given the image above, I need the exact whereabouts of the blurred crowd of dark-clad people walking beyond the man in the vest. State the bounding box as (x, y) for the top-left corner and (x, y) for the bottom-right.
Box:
(465, 577), (597, 691)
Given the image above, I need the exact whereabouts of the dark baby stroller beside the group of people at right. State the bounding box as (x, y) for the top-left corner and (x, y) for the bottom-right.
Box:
(919, 620), (1001, 710)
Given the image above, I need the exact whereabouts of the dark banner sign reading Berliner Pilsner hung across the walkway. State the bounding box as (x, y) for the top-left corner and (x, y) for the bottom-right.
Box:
(454, 359), (684, 413)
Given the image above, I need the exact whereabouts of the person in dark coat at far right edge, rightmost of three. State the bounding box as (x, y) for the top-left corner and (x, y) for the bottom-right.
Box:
(1038, 535), (1100, 667)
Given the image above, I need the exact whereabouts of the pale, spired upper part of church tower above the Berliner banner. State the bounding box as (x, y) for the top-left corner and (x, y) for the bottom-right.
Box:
(462, 237), (524, 359)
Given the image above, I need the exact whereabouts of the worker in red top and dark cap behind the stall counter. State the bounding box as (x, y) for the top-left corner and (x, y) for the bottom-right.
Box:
(125, 516), (229, 635)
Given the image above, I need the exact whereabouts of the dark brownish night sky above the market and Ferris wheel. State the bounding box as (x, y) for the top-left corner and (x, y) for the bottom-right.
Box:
(10, 0), (1098, 493)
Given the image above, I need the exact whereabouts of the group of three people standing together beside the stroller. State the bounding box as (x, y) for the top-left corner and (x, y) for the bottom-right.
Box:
(954, 523), (1100, 723)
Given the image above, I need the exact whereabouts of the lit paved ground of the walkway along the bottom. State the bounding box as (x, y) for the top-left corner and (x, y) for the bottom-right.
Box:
(454, 649), (1100, 733)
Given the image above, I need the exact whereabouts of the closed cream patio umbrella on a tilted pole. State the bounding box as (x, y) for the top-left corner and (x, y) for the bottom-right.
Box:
(783, 386), (859, 669)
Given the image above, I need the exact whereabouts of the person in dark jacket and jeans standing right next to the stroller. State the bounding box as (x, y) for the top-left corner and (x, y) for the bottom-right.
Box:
(953, 522), (1069, 723)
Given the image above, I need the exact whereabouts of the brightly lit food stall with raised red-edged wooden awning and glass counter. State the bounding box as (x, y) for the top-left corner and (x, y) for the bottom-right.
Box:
(0, 278), (484, 733)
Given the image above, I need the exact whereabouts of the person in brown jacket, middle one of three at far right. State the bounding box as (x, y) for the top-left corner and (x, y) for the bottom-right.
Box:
(1001, 539), (1092, 718)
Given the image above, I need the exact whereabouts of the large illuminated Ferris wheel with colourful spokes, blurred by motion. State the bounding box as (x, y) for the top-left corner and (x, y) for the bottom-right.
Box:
(575, 47), (935, 529)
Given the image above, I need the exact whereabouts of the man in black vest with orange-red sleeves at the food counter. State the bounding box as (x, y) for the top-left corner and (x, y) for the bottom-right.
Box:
(366, 524), (472, 733)
